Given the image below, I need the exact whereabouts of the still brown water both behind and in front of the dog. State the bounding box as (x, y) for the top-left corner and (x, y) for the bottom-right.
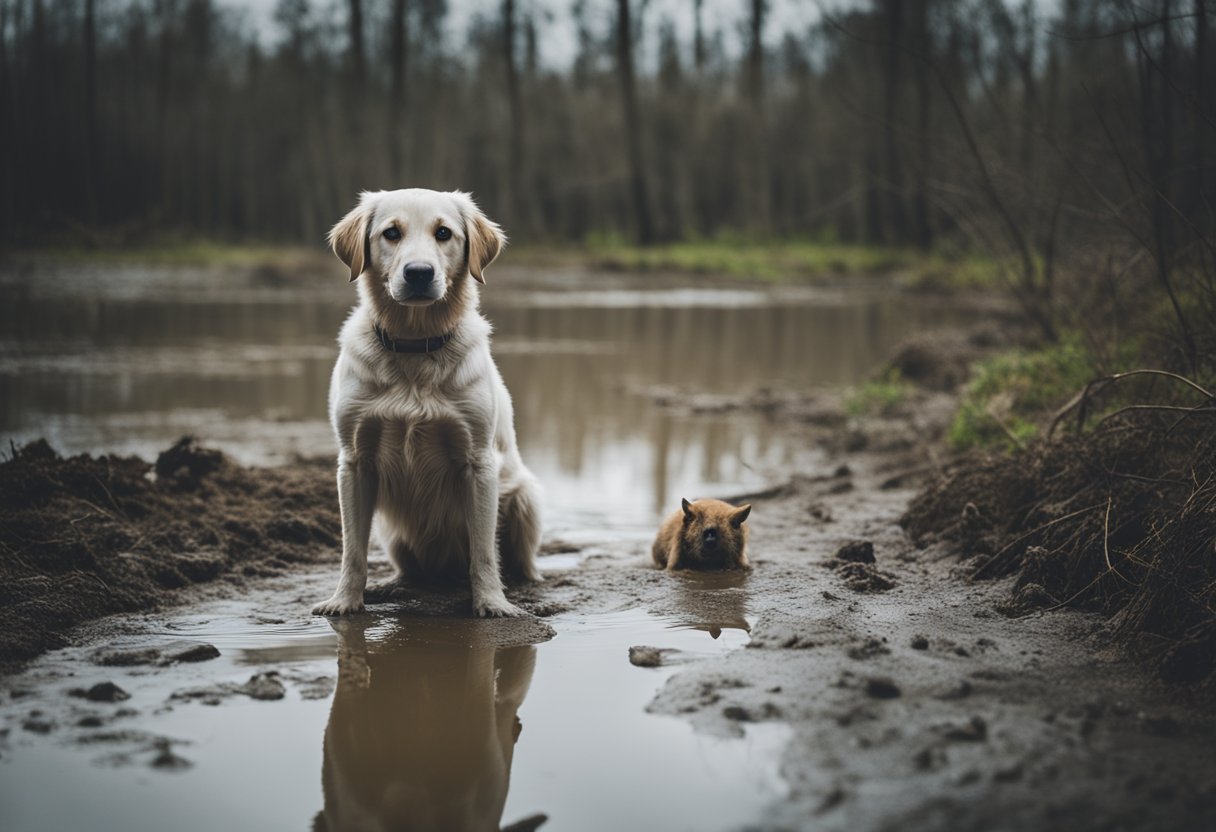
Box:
(0, 257), (964, 831)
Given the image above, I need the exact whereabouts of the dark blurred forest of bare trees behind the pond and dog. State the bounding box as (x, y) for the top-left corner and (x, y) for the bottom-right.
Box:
(0, 0), (1201, 265)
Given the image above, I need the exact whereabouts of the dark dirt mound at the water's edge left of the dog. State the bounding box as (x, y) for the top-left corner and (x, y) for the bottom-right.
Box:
(0, 438), (342, 664)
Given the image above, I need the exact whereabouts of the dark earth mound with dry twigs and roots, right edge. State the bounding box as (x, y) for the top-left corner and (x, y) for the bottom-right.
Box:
(902, 411), (1216, 680)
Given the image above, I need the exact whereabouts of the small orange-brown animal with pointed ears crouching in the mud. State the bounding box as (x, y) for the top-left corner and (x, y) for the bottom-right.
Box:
(651, 500), (751, 572)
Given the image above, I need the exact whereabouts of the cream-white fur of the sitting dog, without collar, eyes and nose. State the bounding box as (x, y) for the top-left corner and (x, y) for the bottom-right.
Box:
(313, 189), (540, 615)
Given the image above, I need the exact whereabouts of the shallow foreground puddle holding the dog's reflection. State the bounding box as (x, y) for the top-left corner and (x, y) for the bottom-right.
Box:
(0, 601), (789, 832)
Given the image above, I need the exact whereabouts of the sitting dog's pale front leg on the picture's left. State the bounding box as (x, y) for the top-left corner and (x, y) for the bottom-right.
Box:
(313, 452), (379, 615)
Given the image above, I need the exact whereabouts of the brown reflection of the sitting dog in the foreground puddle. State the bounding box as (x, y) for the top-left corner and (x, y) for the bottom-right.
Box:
(313, 618), (545, 832)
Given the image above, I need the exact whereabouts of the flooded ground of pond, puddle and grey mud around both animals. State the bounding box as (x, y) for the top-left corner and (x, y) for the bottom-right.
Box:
(0, 256), (1216, 832)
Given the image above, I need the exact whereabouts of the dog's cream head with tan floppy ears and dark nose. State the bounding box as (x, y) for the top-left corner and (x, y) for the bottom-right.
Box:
(330, 189), (506, 307)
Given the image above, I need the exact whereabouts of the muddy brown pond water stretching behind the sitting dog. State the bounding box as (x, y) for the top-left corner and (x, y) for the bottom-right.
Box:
(0, 265), (962, 530)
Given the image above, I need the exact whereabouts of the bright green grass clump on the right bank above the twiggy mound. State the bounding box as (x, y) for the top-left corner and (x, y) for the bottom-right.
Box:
(947, 337), (1139, 450)
